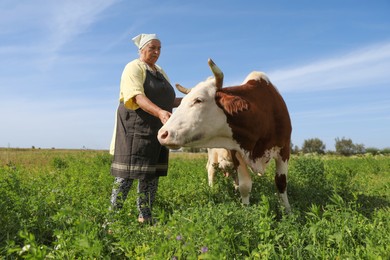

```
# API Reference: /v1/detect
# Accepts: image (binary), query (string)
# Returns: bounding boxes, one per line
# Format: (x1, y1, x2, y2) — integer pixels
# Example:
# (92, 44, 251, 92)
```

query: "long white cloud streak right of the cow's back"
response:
(268, 43, 390, 92)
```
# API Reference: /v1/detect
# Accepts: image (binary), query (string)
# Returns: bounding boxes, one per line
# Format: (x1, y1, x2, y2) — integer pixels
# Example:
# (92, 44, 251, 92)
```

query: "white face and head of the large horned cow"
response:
(158, 59, 242, 149)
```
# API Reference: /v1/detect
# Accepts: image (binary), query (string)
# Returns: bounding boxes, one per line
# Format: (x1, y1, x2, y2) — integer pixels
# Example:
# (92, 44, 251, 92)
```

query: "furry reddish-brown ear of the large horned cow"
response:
(215, 91, 249, 115)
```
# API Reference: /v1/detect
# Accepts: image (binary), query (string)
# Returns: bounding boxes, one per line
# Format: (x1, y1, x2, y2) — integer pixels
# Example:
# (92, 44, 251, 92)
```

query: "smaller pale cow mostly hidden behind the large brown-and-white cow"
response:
(206, 148, 239, 188)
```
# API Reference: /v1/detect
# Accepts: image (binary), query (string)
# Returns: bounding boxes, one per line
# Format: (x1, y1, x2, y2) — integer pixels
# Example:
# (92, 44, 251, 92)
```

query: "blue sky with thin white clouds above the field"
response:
(0, 0, 390, 150)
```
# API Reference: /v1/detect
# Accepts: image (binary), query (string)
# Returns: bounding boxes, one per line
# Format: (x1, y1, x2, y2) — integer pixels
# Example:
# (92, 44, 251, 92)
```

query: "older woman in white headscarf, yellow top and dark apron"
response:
(110, 34, 181, 223)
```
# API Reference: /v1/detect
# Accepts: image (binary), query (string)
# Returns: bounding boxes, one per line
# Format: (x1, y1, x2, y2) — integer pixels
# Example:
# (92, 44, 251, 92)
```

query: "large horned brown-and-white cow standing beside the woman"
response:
(158, 59, 292, 212)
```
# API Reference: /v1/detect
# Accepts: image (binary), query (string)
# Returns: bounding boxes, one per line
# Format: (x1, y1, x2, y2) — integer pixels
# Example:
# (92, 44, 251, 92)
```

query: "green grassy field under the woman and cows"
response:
(0, 149, 390, 259)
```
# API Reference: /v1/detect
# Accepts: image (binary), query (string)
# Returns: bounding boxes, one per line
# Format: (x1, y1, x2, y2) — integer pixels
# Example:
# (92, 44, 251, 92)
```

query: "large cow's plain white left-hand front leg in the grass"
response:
(235, 152, 252, 205)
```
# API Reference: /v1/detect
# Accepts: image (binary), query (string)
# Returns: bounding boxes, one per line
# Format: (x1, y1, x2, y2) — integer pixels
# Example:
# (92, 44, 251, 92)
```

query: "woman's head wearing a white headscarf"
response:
(133, 34, 161, 65)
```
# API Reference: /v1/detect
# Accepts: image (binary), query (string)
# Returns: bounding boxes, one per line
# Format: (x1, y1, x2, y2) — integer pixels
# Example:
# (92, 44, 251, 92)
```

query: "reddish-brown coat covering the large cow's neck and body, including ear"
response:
(215, 79, 292, 161)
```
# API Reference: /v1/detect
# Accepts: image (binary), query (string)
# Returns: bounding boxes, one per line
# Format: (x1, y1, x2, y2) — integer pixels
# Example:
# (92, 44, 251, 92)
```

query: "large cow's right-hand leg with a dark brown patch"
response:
(275, 157, 291, 213)
